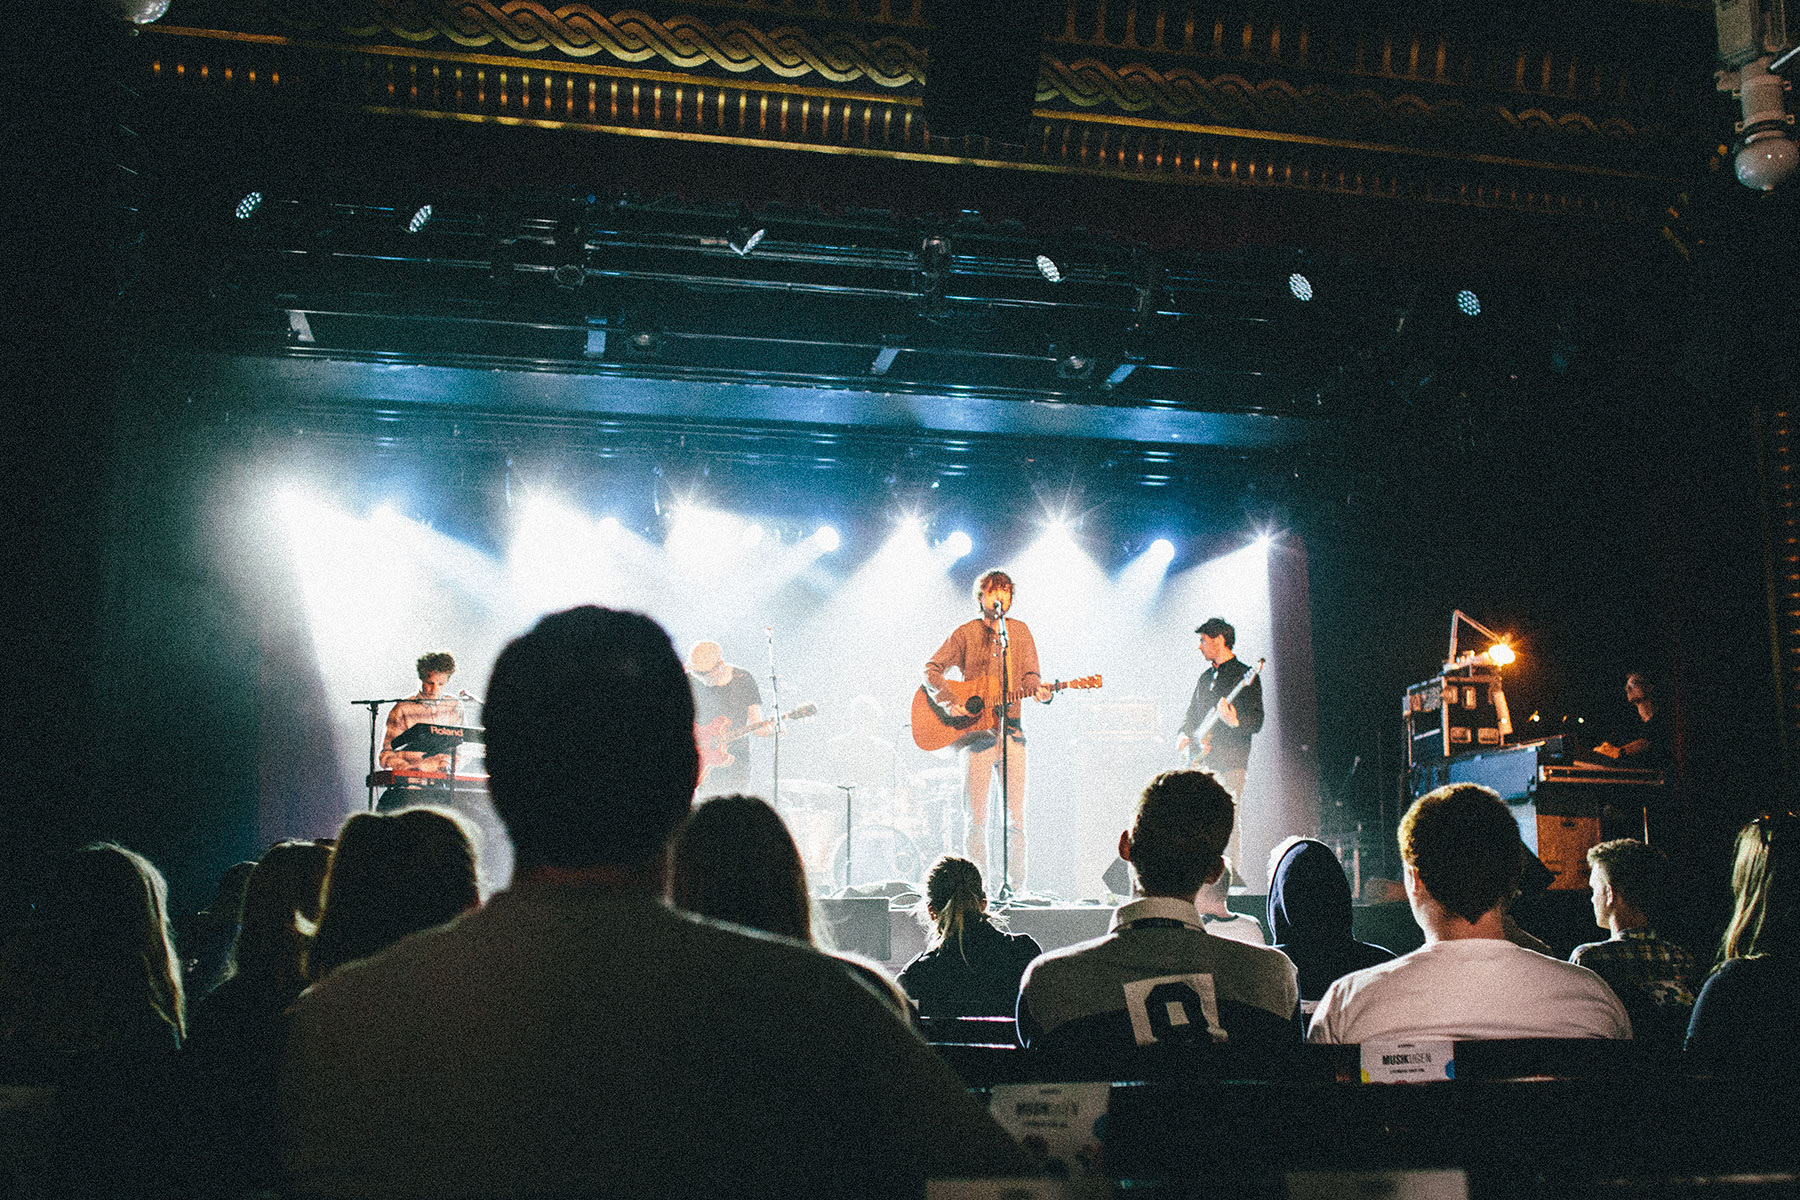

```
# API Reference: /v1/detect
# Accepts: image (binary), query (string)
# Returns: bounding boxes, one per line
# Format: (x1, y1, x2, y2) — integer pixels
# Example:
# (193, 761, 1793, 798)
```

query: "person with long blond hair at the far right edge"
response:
(1687, 813, 1800, 1074)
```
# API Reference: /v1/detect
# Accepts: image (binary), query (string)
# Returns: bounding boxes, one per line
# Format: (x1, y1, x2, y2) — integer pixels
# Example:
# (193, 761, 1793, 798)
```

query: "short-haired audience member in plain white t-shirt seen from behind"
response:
(1309, 783, 1631, 1043)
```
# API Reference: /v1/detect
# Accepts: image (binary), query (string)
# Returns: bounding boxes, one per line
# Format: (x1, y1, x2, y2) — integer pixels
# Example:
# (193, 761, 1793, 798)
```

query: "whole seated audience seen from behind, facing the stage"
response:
(0, 606, 1800, 1196)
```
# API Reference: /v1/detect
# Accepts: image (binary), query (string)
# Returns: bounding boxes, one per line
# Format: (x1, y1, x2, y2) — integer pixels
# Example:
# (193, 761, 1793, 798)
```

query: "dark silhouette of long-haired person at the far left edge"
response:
(0, 842, 185, 1196)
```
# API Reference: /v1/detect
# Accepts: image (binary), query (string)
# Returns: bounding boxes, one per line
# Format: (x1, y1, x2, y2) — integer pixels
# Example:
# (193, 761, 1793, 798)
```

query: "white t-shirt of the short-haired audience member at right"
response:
(1307, 937, 1631, 1043)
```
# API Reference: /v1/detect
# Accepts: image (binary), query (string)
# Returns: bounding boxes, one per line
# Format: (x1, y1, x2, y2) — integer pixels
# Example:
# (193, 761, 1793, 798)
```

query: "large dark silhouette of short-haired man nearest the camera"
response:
(281, 606, 1026, 1200)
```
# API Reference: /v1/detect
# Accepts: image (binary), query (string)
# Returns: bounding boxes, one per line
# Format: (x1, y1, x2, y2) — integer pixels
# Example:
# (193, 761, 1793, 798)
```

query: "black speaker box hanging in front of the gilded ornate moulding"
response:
(923, 0, 1044, 146)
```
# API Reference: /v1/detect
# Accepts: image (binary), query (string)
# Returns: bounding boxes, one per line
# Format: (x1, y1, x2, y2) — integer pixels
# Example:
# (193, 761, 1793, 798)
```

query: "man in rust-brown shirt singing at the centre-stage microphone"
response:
(925, 570, 1055, 887)
